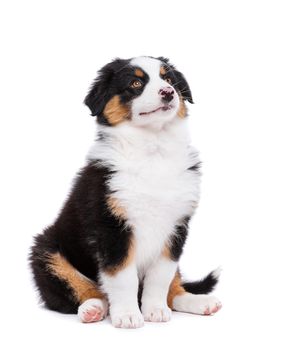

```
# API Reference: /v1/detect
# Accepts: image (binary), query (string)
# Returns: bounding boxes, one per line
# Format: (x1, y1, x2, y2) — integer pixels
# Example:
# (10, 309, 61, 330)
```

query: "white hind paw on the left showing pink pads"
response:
(77, 298, 108, 323)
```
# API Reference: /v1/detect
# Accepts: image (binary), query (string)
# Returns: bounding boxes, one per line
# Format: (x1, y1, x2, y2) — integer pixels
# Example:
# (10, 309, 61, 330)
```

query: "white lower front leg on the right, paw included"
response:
(141, 255, 177, 322)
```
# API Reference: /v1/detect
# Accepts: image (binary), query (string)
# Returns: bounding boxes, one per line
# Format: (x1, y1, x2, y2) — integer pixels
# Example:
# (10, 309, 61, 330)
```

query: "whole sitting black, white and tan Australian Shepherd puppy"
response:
(30, 57, 221, 328)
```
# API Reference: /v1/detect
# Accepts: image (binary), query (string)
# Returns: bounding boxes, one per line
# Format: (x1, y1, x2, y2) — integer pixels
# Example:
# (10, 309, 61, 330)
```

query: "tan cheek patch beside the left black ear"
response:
(103, 95, 130, 125)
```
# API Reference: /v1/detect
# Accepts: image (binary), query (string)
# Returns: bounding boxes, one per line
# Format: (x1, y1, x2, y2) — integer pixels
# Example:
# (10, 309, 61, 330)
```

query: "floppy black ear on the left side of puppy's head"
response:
(84, 58, 125, 124)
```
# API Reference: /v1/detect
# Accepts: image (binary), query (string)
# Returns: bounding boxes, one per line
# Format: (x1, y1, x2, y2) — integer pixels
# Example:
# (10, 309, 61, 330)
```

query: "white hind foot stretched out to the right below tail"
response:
(173, 293, 222, 315)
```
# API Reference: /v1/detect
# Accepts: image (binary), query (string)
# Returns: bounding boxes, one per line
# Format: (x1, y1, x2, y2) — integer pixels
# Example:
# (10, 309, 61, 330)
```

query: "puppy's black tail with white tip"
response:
(182, 267, 221, 294)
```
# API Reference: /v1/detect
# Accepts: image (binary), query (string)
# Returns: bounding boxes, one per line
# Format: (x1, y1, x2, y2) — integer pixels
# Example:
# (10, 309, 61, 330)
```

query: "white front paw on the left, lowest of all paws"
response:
(110, 310, 144, 328)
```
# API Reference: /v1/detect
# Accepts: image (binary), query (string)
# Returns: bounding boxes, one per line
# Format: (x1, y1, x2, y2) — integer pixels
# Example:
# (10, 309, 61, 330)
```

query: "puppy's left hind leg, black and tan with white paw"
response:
(30, 241, 108, 322)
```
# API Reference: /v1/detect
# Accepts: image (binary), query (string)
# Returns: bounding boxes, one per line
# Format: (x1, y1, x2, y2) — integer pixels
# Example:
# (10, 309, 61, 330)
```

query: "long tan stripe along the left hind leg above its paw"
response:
(47, 253, 104, 303)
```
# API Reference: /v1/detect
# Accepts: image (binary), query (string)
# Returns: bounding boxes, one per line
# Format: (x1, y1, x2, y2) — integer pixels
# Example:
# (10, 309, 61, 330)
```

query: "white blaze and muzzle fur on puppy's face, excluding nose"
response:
(130, 57, 180, 126)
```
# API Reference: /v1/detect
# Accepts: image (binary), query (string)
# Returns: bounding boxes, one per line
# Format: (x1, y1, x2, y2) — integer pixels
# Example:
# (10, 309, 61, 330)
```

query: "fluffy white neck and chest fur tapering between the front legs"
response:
(88, 120, 199, 270)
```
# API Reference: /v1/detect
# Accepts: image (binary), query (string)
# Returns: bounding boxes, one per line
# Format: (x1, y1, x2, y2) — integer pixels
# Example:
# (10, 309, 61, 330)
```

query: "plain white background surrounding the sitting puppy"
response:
(0, 0, 289, 350)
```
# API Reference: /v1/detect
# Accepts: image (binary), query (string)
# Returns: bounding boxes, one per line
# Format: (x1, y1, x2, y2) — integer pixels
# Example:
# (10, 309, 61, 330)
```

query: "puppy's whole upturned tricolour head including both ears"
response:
(84, 57, 193, 127)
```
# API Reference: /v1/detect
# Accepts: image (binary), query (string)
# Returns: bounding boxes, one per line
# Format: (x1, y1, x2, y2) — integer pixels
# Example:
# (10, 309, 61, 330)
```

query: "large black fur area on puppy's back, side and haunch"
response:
(30, 162, 132, 313)
